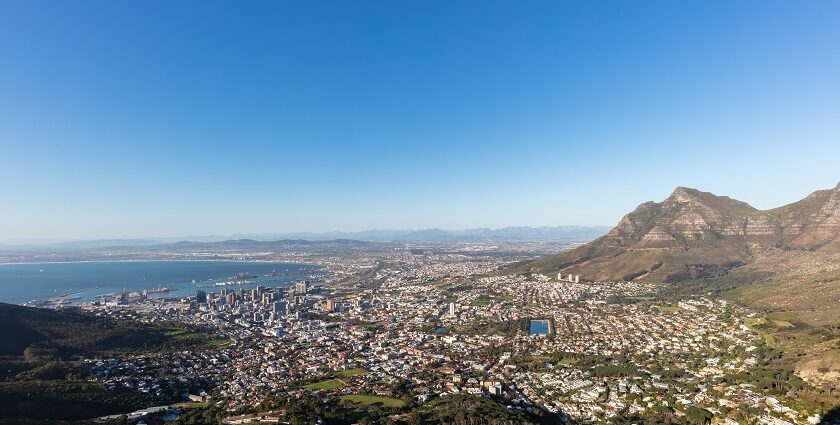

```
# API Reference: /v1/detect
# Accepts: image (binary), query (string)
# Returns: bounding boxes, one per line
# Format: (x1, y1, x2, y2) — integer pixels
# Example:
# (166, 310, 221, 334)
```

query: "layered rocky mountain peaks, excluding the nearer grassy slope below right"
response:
(530, 184, 840, 281)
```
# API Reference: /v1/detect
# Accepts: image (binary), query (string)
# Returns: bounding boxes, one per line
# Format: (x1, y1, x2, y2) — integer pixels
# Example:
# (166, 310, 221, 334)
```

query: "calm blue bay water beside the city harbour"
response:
(0, 261, 321, 304)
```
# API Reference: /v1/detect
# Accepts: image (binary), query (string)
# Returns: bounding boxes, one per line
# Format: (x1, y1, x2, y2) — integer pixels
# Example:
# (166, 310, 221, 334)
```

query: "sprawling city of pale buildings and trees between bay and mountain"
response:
(70, 244, 819, 425)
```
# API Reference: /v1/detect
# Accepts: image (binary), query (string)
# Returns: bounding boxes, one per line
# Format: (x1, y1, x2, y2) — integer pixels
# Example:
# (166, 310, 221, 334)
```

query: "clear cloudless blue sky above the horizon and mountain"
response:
(0, 0, 840, 240)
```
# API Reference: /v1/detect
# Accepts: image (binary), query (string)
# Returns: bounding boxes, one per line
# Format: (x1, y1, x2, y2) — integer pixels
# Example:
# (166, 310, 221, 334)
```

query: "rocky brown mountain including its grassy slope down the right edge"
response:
(528, 185, 840, 388)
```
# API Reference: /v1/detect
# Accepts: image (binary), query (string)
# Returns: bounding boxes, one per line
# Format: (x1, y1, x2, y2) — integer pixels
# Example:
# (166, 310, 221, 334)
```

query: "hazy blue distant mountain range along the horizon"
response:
(0, 226, 609, 250)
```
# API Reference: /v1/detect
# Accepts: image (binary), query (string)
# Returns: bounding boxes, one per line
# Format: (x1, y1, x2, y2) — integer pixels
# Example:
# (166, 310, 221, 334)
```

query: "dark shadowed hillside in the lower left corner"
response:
(0, 303, 223, 424)
